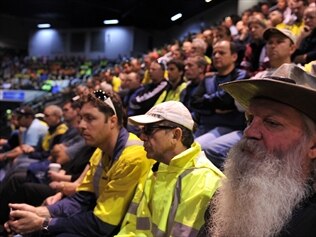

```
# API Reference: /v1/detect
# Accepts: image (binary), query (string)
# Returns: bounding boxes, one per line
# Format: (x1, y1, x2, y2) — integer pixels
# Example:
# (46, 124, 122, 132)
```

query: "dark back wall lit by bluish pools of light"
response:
(0, 0, 237, 59)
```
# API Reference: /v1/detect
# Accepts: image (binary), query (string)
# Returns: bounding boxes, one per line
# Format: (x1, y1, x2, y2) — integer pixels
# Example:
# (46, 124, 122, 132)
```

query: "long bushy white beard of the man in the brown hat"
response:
(208, 138, 309, 237)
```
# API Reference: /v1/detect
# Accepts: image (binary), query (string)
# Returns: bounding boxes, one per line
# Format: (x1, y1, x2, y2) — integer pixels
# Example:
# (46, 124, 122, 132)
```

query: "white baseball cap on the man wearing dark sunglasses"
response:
(128, 101, 194, 131)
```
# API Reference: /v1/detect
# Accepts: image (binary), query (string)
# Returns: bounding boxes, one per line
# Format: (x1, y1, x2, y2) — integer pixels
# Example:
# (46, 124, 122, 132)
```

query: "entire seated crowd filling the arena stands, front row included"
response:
(0, 0, 316, 237)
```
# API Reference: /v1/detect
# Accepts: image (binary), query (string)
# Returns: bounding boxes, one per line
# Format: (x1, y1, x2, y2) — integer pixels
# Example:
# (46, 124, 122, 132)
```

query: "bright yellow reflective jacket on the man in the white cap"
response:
(117, 143, 224, 237)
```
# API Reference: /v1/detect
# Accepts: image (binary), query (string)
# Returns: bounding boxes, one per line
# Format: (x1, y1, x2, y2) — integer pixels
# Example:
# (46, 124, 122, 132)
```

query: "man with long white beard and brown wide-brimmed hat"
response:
(199, 64, 316, 236)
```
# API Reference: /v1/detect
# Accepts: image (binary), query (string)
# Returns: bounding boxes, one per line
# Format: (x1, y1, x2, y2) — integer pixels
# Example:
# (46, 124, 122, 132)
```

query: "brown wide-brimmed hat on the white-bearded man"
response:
(220, 64, 316, 121)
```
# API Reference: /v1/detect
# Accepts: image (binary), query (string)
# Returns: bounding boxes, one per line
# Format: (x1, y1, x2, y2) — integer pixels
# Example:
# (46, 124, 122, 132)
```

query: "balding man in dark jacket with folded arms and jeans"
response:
(191, 40, 247, 149)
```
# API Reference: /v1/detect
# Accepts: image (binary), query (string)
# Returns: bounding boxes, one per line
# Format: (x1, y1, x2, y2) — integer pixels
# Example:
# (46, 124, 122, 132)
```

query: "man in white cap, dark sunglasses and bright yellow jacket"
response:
(118, 101, 223, 236)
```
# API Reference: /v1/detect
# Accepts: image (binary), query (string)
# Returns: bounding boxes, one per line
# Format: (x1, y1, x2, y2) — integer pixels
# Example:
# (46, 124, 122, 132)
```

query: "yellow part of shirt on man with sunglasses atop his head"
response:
(77, 133, 153, 225)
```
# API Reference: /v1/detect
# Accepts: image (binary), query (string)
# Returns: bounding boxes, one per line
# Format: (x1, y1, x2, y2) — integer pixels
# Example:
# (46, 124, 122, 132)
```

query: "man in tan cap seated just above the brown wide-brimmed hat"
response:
(254, 28, 296, 78)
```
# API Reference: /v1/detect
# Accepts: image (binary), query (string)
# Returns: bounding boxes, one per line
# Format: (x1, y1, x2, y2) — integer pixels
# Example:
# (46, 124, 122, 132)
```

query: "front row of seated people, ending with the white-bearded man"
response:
(0, 60, 316, 237)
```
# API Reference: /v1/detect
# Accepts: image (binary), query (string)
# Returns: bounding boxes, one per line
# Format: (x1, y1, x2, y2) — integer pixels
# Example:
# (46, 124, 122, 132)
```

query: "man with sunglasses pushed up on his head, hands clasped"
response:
(5, 91, 152, 237)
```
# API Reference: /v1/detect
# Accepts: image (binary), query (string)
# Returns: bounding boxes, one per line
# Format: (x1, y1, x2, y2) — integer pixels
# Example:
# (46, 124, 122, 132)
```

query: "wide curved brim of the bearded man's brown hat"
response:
(220, 78, 316, 121)
